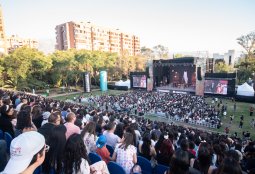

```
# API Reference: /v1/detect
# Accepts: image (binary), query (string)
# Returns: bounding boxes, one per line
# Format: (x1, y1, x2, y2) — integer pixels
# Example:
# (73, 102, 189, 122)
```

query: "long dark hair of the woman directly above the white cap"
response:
(16, 110, 32, 131)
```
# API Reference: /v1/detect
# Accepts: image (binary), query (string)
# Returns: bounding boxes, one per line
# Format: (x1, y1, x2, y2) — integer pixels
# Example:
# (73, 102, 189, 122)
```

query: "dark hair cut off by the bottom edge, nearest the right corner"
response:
(217, 158, 242, 174)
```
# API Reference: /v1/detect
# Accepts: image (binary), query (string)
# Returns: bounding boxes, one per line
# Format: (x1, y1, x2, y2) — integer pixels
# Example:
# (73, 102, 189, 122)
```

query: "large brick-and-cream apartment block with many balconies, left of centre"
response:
(55, 21, 140, 56)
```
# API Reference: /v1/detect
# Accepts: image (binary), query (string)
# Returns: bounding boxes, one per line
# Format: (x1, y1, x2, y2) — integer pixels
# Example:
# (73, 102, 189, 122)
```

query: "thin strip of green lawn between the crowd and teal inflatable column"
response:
(52, 90, 128, 100)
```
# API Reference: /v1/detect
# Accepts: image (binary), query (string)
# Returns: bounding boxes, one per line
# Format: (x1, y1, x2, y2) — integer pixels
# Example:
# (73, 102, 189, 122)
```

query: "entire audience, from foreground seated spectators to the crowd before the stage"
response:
(0, 90, 255, 174)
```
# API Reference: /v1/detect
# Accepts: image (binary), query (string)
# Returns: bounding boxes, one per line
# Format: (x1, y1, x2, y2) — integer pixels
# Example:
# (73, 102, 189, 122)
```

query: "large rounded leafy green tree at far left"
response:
(4, 47, 51, 89)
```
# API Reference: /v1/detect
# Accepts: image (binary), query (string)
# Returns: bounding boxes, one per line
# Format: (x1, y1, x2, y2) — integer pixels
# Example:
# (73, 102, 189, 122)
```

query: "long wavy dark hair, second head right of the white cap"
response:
(63, 134, 88, 174)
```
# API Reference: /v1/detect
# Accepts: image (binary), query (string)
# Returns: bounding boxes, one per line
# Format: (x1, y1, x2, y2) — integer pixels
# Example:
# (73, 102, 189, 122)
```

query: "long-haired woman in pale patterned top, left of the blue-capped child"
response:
(81, 121, 97, 153)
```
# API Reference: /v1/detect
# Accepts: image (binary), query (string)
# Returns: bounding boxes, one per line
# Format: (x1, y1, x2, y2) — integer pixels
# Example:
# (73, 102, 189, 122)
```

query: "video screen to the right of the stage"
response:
(205, 79, 228, 95)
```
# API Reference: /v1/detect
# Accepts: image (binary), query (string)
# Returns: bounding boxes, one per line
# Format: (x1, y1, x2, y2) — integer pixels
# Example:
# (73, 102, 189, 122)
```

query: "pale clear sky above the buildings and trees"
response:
(0, 0, 255, 53)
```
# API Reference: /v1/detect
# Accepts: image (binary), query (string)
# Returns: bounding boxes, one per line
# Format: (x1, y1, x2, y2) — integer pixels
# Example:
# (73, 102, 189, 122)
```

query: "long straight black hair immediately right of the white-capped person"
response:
(43, 125, 66, 173)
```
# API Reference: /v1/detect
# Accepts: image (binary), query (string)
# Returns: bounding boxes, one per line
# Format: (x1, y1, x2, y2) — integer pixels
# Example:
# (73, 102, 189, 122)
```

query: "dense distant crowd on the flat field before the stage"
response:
(85, 91, 221, 127)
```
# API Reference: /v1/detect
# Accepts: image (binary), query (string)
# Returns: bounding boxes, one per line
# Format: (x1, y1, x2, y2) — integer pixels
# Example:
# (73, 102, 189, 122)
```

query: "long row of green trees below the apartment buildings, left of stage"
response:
(0, 47, 146, 89)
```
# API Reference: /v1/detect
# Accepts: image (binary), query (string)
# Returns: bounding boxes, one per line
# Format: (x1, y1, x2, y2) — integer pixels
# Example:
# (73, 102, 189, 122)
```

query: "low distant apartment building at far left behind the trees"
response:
(6, 35, 38, 53)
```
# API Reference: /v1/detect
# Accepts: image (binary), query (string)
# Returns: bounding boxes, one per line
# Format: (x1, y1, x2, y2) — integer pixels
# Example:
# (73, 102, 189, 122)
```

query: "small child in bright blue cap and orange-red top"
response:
(96, 135, 113, 164)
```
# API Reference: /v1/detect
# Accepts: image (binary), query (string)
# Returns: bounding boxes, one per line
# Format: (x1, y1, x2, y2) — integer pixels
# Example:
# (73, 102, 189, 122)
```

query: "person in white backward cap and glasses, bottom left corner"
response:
(1, 131, 46, 174)
